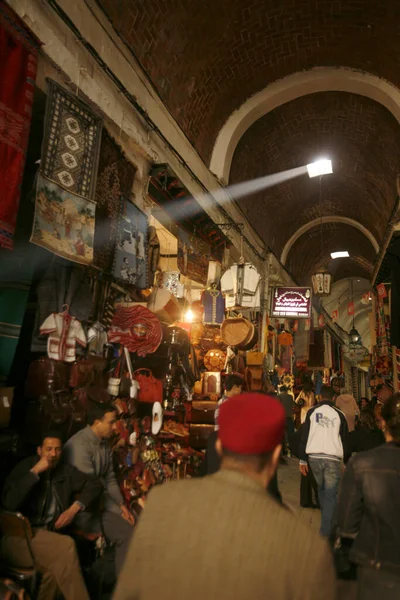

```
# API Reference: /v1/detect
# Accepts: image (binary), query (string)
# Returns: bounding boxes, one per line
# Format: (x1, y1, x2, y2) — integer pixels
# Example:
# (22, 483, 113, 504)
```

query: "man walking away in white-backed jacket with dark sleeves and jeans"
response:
(299, 386, 350, 537)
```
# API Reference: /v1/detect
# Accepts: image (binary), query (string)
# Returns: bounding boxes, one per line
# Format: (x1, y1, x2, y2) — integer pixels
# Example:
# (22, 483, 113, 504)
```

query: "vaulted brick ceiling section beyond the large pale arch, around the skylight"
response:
(231, 92, 400, 277)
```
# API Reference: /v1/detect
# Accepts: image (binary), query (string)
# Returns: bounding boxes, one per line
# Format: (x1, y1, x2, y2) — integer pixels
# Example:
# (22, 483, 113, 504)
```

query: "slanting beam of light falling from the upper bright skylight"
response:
(162, 165, 307, 220)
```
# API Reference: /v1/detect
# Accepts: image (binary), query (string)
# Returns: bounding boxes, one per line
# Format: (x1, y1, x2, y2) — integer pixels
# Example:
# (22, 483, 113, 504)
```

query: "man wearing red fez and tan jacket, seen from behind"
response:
(114, 393, 336, 600)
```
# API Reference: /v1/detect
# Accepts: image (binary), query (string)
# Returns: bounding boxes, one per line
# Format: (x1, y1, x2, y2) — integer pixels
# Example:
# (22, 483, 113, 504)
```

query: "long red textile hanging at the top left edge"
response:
(0, 2, 40, 250)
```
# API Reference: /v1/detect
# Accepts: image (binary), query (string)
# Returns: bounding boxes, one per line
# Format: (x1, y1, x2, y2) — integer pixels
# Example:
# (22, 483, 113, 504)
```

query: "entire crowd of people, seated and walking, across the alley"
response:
(0, 374, 400, 600)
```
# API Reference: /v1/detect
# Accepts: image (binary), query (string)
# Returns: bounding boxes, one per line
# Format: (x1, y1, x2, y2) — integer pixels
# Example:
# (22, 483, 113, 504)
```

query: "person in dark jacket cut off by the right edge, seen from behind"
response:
(338, 394, 400, 600)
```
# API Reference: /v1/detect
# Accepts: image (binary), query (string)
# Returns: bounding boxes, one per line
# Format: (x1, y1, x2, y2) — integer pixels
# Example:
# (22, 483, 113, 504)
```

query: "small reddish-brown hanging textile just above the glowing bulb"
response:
(178, 229, 211, 285)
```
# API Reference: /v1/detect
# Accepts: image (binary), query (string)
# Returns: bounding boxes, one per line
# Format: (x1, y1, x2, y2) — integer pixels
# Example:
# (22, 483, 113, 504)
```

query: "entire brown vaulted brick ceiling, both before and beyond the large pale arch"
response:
(98, 0, 400, 280)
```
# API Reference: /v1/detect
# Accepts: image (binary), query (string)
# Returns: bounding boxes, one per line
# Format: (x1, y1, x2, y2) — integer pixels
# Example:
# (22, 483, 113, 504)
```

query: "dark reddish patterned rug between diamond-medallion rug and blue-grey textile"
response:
(94, 129, 136, 273)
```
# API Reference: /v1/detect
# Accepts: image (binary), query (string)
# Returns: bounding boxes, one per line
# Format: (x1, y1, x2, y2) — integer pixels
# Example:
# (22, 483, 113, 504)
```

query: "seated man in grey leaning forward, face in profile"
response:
(64, 403, 134, 573)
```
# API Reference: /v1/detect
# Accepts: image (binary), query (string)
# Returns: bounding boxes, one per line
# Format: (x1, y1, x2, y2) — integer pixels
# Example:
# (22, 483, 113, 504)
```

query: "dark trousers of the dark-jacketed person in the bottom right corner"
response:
(357, 567, 400, 600)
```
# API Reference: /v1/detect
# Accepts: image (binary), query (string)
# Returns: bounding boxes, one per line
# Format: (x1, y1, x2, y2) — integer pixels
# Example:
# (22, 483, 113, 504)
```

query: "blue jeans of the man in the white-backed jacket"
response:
(308, 456, 342, 537)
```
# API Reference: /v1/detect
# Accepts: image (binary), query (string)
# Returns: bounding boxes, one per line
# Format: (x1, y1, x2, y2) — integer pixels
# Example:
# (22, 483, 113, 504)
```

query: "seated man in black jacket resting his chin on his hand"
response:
(1, 432, 102, 600)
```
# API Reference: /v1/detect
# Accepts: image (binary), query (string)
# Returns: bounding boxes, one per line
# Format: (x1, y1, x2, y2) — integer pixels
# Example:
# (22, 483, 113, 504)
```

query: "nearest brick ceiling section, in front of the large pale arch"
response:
(98, 0, 400, 162)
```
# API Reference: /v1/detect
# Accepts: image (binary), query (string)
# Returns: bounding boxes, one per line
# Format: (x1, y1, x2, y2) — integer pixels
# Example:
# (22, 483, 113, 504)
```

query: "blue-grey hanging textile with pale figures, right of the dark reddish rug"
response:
(113, 200, 148, 290)
